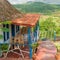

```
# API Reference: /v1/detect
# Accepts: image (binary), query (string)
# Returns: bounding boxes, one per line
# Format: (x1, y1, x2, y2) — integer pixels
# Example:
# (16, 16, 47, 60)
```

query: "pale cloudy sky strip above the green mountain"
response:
(8, 0, 60, 4)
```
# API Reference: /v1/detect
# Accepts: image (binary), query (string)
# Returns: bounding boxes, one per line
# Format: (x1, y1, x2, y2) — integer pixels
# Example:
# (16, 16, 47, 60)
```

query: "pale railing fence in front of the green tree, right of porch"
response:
(39, 31, 56, 40)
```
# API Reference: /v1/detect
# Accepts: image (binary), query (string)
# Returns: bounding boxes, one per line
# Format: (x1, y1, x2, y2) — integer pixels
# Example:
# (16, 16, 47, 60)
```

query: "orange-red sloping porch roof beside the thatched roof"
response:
(12, 14, 40, 27)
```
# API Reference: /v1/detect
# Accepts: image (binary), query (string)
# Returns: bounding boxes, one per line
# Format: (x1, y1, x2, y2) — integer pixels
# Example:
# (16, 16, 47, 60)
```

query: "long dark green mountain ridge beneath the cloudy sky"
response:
(14, 1, 60, 14)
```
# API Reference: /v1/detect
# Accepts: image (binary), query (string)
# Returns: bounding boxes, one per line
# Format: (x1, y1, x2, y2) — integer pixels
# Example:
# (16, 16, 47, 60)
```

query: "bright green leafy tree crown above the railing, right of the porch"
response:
(40, 17, 56, 31)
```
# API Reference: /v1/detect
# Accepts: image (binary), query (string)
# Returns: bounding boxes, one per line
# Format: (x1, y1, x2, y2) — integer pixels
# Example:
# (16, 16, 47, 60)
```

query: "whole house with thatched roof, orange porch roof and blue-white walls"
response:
(0, 0, 40, 58)
